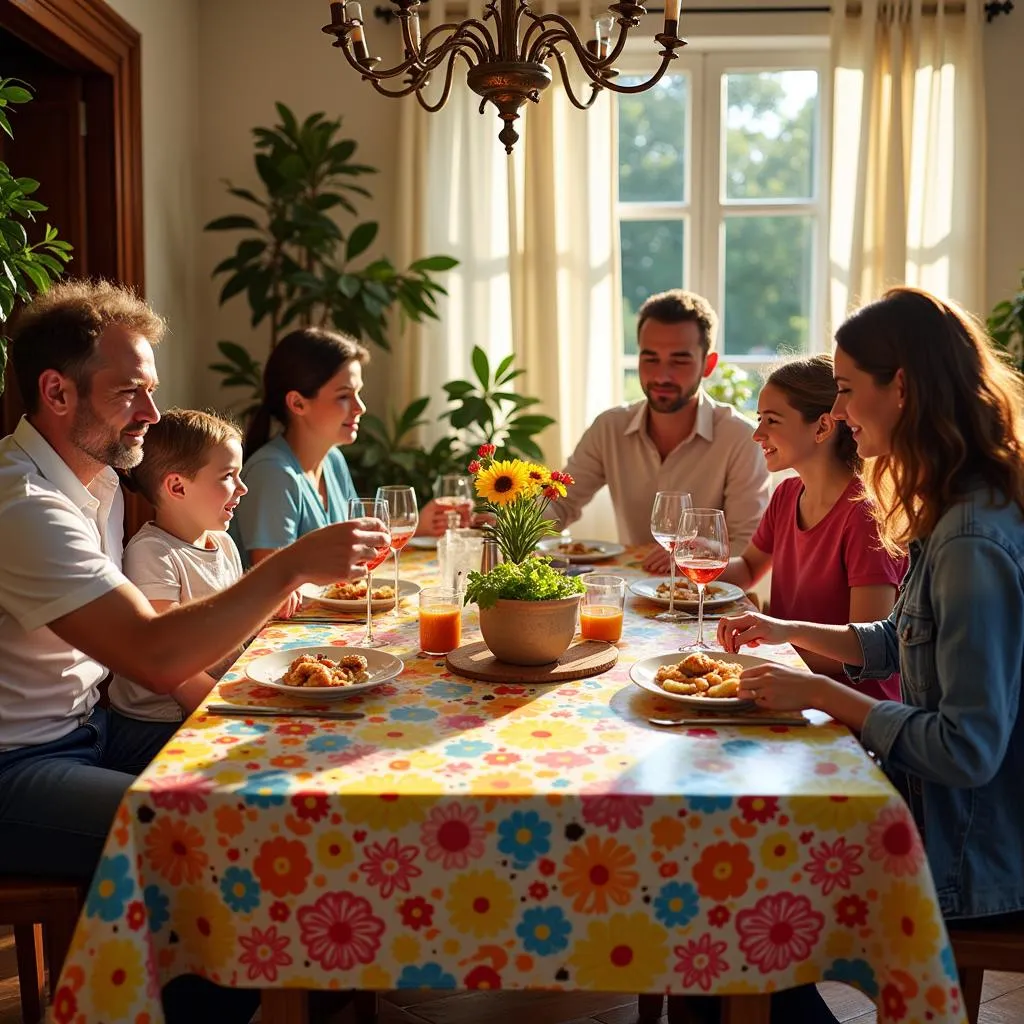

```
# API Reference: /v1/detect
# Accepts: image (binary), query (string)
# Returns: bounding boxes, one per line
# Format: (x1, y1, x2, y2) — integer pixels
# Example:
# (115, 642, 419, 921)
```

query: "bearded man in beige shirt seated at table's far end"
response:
(550, 290, 769, 572)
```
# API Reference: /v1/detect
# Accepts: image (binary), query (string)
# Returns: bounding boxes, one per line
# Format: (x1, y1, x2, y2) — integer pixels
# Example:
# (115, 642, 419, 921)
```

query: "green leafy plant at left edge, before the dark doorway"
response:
(0, 78, 72, 394)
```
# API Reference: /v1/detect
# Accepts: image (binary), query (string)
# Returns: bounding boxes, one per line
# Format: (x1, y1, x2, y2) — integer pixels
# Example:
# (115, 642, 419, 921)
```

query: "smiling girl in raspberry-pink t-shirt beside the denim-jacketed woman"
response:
(722, 355, 906, 700)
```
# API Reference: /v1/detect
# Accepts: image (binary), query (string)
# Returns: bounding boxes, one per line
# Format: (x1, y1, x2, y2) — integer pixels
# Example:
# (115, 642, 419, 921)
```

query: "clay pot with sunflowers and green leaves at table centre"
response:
(466, 444, 584, 665)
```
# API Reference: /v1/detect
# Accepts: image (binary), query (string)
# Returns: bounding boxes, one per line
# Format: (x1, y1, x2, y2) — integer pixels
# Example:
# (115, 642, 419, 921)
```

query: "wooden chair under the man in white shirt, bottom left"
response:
(0, 878, 85, 1024)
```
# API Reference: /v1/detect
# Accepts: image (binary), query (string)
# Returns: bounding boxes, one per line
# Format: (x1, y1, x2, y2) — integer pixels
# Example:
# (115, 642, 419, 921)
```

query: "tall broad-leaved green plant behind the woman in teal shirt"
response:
(206, 103, 458, 407)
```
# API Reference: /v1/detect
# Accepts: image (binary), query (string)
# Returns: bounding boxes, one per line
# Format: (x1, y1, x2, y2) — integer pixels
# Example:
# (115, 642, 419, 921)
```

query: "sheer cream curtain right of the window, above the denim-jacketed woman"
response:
(829, 0, 986, 329)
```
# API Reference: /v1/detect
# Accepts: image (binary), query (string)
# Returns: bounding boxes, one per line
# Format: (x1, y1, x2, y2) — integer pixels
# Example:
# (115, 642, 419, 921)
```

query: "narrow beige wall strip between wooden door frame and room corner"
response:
(102, 0, 200, 408)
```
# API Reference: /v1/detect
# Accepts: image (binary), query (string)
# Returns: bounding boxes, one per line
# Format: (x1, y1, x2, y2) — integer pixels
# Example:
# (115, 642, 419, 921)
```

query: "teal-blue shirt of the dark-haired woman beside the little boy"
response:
(228, 435, 358, 569)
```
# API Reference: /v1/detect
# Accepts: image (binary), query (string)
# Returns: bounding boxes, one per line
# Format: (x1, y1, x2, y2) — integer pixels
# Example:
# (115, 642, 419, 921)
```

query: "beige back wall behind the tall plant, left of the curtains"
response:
(198, 0, 398, 408)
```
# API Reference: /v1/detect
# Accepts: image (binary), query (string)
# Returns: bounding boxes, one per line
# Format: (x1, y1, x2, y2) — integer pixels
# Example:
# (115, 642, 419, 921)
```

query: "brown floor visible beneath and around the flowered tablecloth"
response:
(0, 929, 1024, 1024)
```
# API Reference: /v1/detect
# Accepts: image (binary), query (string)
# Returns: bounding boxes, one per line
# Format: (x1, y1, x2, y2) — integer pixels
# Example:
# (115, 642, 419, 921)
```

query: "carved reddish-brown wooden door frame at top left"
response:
(0, 0, 145, 295)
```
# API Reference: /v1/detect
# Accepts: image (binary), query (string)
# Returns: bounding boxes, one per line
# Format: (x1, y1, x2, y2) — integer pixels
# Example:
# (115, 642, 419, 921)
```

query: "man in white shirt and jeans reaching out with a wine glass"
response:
(0, 282, 386, 879)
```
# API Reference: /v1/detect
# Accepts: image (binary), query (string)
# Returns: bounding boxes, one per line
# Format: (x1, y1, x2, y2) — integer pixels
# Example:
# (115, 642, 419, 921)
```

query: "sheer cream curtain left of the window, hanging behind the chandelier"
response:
(398, 0, 622, 475)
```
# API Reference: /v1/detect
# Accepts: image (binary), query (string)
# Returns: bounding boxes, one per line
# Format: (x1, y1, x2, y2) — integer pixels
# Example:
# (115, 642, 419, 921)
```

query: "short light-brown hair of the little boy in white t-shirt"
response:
(131, 409, 242, 505)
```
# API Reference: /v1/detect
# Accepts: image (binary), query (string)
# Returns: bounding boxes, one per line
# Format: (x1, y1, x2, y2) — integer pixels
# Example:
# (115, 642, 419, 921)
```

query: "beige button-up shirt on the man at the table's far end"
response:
(548, 390, 769, 555)
